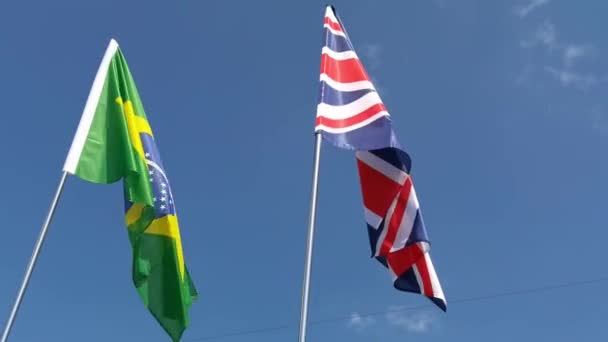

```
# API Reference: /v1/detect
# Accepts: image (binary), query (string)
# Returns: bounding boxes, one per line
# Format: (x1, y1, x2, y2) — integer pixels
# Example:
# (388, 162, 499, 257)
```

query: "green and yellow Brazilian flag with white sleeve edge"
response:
(64, 40, 197, 341)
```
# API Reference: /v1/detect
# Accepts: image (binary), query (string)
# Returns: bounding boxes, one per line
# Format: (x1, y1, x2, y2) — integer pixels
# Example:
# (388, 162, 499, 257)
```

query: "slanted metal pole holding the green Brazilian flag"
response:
(0, 171, 68, 342)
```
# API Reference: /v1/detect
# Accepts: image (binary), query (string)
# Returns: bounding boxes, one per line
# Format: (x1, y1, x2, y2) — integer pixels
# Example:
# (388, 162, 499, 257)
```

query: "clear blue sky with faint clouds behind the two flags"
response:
(0, 0, 608, 342)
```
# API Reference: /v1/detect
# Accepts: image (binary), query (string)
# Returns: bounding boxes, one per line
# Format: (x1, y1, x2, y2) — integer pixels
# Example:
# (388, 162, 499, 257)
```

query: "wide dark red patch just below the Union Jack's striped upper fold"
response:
(357, 159, 401, 217)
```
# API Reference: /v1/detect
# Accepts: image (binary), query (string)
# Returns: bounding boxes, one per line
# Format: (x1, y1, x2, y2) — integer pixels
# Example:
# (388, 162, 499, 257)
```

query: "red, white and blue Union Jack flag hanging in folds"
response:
(315, 6, 447, 311)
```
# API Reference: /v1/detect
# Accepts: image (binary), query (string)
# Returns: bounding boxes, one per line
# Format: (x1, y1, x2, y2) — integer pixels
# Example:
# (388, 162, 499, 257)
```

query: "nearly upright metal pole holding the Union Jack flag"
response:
(299, 133, 321, 342)
